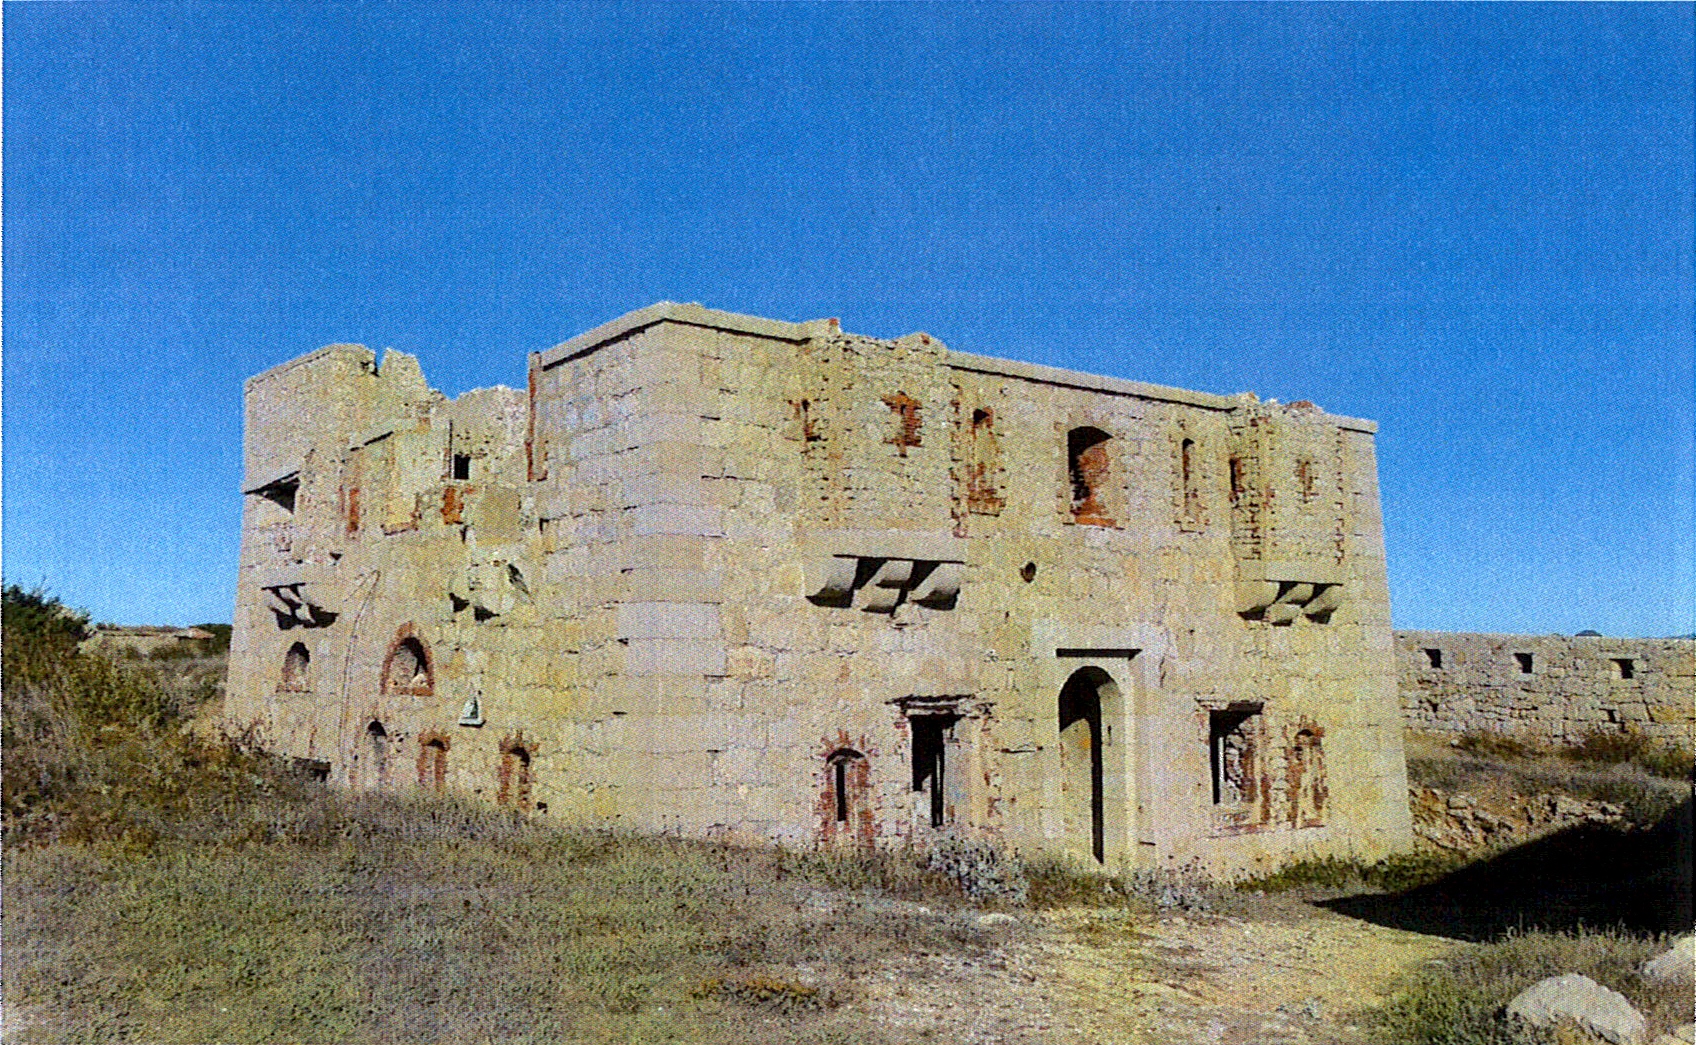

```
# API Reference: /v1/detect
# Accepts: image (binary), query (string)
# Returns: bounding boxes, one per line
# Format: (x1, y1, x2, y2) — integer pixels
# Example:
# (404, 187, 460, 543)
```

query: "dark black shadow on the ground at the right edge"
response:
(1323, 787, 1696, 942)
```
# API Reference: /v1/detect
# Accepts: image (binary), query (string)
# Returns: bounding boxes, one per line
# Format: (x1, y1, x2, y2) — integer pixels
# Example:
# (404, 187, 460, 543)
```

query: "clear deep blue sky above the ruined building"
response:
(3, 2, 1696, 634)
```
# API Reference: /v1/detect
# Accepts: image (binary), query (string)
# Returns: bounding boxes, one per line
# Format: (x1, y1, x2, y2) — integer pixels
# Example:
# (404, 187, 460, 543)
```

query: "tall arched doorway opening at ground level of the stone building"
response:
(1058, 667, 1121, 863)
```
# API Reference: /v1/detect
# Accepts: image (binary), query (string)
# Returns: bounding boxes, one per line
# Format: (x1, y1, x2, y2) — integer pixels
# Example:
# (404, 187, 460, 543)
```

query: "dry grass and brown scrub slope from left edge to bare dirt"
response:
(0, 590, 977, 1045)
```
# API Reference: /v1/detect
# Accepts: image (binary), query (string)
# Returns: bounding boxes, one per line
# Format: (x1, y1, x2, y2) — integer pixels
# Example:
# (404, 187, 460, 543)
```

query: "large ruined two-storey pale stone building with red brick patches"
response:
(226, 304, 1409, 870)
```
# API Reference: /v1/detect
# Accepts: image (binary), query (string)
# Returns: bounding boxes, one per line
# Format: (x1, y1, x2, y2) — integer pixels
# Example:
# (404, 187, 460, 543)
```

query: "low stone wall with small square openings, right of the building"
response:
(1396, 631, 1696, 748)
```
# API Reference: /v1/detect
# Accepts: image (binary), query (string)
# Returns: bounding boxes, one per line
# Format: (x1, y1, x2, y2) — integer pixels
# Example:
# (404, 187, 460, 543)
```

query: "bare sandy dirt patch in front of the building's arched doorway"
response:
(776, 899, 1453, 1045)
